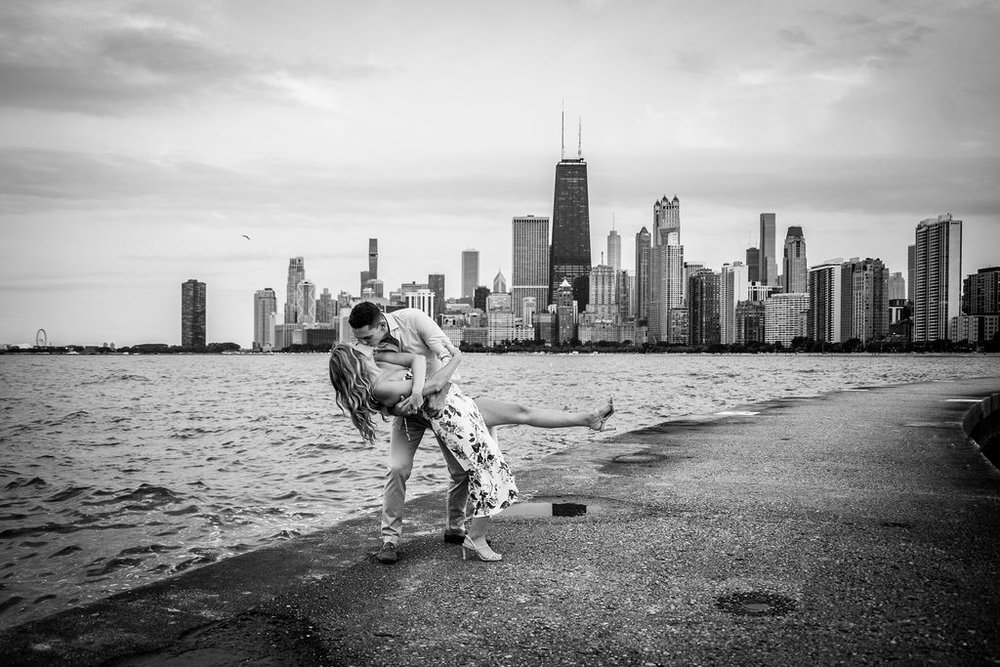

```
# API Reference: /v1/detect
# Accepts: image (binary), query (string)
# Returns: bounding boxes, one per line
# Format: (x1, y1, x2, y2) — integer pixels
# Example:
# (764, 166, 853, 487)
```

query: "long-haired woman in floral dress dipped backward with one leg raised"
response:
(330, 344, 614, 561)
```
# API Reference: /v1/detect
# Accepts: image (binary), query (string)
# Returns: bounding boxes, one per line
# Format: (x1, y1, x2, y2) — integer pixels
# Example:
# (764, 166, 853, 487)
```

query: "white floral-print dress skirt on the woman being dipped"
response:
(424, 384, 517, 517)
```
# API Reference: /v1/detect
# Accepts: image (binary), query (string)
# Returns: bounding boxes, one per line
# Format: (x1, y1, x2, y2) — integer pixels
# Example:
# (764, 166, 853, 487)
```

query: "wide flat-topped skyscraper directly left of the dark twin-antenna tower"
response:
(510, 215, 549, 324)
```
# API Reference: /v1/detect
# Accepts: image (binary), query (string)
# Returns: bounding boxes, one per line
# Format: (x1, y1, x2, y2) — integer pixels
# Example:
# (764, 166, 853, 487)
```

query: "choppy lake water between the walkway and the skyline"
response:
(0, 355, 1000, 627)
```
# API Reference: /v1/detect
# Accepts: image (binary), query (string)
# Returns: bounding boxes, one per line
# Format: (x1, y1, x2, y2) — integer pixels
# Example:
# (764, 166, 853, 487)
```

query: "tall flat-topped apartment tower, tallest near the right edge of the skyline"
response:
(913, 213, 962, 342)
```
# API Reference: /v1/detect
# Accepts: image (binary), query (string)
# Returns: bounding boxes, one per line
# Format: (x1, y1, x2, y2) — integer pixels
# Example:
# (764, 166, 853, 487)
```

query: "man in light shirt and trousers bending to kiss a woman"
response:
(347, 301, 469, 564)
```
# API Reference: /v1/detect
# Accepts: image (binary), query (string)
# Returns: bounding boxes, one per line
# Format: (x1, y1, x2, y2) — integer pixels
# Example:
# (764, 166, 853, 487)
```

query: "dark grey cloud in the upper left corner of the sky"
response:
(0, 2, 379, 116)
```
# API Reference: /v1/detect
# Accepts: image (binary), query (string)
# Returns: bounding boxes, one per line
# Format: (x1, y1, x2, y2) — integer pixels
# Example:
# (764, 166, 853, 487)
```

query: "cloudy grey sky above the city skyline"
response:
(0, 0, 1000, 346)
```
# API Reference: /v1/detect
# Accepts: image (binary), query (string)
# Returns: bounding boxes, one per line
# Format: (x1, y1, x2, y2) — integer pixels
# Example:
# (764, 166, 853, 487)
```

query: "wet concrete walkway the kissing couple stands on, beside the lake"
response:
(0, 378, 1000, 665)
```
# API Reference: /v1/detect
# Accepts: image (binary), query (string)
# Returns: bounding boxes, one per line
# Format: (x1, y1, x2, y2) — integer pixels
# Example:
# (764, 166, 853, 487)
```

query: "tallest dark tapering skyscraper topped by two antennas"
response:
(549, 116, 592, 311)
